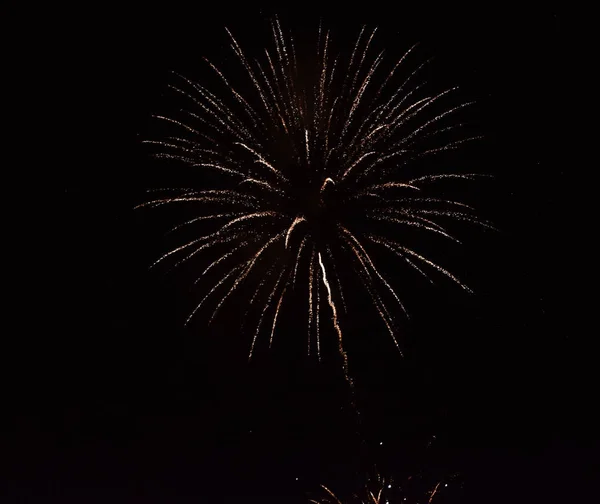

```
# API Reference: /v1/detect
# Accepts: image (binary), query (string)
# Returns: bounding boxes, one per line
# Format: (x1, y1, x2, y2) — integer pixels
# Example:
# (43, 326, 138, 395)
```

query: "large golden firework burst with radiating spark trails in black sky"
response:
(140, 19, 491, 370)
